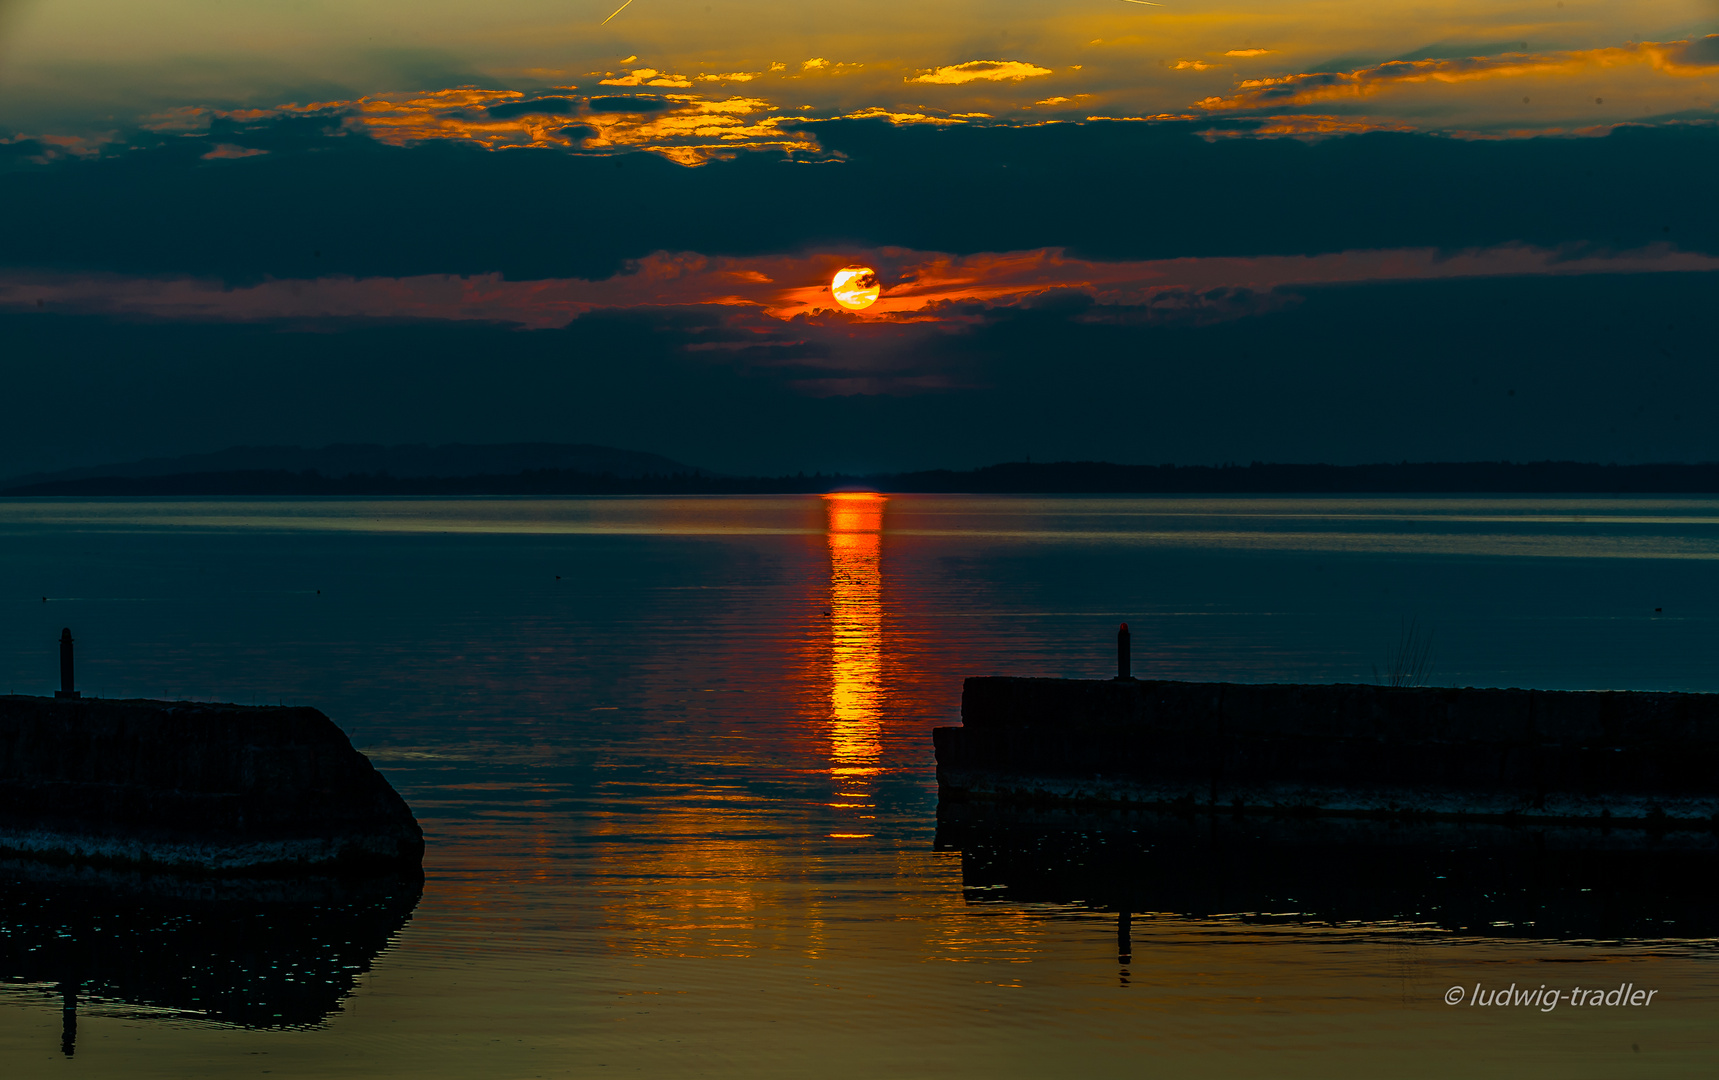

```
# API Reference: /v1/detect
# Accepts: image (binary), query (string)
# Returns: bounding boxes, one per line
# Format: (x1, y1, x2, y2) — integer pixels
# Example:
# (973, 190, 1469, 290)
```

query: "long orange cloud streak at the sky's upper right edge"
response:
(1195, 34, 1719, 112)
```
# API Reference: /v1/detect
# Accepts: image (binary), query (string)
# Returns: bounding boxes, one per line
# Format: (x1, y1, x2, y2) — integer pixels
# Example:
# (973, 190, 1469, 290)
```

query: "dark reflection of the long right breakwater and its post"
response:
(937, 801, 1719, 954)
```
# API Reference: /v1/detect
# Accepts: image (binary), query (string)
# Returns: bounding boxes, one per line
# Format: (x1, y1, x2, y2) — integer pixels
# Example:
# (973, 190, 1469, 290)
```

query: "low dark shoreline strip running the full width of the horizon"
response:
(10, 461, 1719, 499)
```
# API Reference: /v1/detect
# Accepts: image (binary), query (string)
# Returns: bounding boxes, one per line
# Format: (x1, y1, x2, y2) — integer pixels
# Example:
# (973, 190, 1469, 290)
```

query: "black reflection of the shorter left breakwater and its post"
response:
(0, 860, 423, 1056)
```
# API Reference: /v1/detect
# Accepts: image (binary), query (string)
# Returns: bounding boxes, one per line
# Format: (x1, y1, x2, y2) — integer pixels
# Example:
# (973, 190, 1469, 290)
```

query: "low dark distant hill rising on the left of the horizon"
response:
(0, 442, 708, 488)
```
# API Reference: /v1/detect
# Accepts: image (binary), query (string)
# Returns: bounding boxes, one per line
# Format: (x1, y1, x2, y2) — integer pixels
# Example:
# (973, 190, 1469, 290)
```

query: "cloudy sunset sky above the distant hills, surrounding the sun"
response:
(0, 0, 1719, 475)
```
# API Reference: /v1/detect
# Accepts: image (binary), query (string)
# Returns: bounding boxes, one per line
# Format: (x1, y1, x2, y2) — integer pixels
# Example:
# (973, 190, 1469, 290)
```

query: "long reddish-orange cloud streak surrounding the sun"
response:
(0, 244, 1719, 328)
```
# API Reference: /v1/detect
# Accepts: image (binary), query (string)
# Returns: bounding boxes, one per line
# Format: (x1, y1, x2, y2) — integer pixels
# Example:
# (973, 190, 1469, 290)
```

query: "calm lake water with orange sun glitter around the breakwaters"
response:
(0, 495, 1719, 1078)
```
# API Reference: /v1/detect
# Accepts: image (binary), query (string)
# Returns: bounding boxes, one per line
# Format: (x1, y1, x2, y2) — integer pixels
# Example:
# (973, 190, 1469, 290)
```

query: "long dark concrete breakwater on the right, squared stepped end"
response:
(933, 678, 1719, 829)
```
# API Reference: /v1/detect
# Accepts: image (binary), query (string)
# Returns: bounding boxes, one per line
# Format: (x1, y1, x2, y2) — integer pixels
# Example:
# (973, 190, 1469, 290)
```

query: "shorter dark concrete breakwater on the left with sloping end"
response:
(0, 696, 425, 874)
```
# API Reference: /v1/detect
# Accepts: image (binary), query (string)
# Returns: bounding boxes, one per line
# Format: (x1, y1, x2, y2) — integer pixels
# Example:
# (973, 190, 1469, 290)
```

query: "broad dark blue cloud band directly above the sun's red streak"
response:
(0, 117, 1719, 282)
